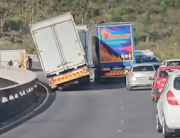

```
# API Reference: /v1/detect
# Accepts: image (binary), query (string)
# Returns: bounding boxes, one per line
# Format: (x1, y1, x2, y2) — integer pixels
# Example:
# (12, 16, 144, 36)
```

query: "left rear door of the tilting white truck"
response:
(32, 26, 64, 74)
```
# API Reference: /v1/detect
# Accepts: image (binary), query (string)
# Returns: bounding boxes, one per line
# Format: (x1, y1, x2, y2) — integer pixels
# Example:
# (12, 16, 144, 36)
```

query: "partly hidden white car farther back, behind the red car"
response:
(161, 59, 180, 67)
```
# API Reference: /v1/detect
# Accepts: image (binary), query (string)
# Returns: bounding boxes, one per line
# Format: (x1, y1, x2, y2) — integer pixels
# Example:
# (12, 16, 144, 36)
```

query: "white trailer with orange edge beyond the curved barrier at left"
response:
(0, 49, 26, 69)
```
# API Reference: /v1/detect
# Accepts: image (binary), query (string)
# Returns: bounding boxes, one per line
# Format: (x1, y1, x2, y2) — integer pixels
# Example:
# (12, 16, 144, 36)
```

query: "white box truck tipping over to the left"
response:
(30, 13, 90, 89)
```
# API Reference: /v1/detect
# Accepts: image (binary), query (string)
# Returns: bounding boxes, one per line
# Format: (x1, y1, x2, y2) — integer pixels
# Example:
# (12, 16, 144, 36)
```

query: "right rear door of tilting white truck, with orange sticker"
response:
(54, 19, 85, 68)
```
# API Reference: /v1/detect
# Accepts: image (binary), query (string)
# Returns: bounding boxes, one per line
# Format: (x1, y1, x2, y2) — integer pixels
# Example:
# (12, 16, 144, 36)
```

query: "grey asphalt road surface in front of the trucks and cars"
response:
(0, 62, 162, 138)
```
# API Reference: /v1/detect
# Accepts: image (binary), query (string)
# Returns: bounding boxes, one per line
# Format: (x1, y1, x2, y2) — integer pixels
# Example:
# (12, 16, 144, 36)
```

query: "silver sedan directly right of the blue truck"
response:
(126, 64, 156, 91)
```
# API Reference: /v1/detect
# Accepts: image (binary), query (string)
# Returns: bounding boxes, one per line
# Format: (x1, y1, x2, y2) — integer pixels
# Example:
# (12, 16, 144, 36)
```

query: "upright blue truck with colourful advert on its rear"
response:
(91, 23, 136, 81)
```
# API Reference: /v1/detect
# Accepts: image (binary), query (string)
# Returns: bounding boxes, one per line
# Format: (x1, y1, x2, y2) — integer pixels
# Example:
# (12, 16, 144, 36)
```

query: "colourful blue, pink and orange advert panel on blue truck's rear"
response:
(98, 24, 134, 63)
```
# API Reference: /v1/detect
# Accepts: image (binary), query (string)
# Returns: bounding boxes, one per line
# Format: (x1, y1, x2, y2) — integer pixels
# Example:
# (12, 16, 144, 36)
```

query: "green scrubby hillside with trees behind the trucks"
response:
(0, 0, 180, 59)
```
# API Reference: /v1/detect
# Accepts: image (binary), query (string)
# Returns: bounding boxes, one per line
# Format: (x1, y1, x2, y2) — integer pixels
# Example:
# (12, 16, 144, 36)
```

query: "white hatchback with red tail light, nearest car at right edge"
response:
(156, 71, 180, 138)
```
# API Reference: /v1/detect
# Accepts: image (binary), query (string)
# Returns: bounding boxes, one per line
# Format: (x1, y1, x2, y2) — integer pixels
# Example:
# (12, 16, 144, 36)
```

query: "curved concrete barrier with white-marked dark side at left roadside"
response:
(0, 66, 39, 121)
